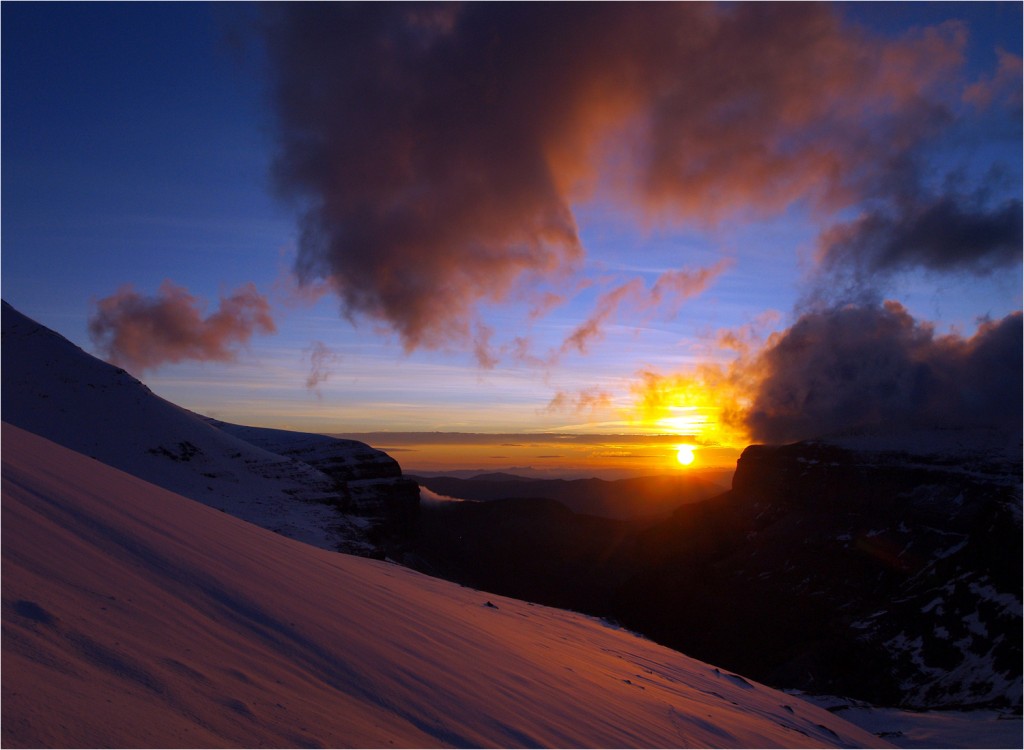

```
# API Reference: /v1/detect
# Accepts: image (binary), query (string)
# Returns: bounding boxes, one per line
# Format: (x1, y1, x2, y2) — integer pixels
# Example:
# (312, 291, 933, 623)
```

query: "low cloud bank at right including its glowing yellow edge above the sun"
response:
(633, 301, 1024, 445)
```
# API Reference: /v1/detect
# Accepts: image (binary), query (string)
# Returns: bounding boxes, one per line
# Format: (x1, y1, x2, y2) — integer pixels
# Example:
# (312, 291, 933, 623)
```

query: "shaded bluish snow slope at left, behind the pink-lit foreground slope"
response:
(2, 302, 386, 553)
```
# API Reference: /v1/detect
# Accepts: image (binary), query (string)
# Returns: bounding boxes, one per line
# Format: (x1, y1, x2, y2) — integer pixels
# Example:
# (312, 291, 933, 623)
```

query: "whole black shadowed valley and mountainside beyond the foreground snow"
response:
(407, 431, 1022, 710)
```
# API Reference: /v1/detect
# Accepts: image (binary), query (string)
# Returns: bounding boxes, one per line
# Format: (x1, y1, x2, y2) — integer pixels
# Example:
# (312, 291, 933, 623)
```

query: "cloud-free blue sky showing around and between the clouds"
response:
(2, 3, 1021, 469)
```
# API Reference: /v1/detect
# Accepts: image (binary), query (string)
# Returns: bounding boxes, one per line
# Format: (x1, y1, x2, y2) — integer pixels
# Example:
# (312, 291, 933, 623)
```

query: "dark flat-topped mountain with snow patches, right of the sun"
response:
(616, 435, 1022, 708)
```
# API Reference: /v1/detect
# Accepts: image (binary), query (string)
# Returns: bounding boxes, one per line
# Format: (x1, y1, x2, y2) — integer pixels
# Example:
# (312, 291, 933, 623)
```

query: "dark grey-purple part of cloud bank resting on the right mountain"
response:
(742, 302, 1024, 443)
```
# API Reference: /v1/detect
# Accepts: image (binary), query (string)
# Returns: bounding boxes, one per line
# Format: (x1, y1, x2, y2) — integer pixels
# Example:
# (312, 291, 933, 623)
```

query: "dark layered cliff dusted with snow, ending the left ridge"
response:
(211, 420, 420, 555)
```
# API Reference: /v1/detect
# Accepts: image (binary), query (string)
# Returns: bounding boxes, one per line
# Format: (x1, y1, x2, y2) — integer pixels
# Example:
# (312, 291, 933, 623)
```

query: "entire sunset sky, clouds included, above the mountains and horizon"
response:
(0, 2, 1022, 475)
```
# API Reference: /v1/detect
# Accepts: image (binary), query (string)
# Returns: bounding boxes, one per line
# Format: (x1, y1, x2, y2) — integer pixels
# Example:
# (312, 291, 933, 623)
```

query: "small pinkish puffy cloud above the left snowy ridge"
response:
(89, 281, 276, 372)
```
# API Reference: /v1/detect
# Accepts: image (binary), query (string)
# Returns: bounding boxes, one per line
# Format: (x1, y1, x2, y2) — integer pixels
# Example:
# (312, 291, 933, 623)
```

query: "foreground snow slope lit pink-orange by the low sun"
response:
(2, 424, 886, 747)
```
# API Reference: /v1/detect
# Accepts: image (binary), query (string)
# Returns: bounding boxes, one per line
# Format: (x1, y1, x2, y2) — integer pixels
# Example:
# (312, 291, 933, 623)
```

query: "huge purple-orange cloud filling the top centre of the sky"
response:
(265, 3, 966, 352)
